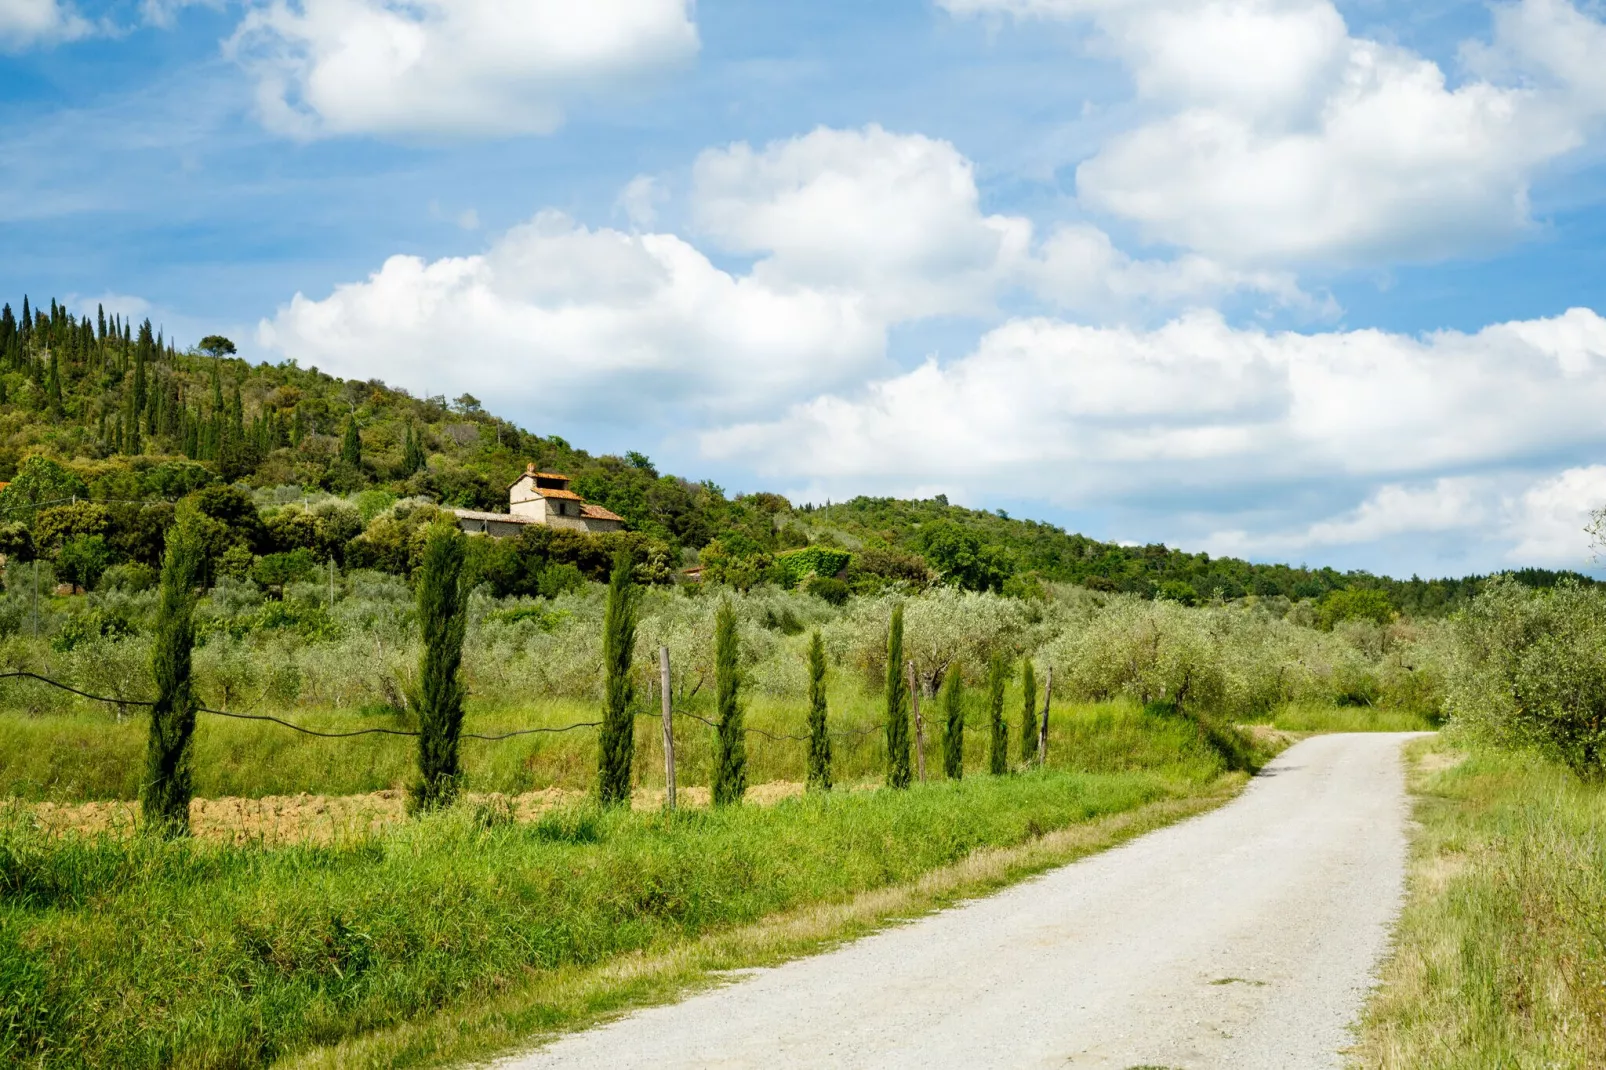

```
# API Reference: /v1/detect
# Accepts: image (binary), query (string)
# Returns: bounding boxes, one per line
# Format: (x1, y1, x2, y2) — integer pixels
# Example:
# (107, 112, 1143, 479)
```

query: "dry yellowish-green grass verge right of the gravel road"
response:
(1354, 739, 1606, 1070)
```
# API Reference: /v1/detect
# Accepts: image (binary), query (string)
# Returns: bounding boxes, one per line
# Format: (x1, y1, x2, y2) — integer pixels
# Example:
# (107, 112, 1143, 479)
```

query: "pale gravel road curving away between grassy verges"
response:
(501, 734, 1408, 1070)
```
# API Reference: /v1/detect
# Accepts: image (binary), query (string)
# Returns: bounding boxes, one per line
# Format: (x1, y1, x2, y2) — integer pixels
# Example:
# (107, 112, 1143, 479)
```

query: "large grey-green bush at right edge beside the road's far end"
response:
(1445, 578, 1606, 781)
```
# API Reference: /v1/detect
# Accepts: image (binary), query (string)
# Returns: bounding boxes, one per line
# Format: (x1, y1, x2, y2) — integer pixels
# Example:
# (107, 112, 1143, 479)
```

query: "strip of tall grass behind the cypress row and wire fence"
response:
(0, 684, 1233, 803)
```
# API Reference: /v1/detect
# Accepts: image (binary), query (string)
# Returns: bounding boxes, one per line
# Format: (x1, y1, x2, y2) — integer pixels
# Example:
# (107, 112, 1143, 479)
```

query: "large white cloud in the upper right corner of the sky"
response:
(944, 0, 1606, 265)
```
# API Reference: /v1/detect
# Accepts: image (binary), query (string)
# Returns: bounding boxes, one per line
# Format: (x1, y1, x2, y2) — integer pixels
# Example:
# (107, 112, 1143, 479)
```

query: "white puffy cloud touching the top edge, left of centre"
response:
(228, 0, 699, 137)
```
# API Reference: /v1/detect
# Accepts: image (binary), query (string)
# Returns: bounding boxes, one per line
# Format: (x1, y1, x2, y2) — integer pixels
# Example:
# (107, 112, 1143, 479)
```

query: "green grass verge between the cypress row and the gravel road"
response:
(0, 748, 1243, 1068)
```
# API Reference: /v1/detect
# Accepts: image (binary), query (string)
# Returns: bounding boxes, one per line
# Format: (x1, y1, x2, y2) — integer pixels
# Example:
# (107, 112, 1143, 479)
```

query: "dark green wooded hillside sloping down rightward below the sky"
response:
(0, 297, 1588, 614)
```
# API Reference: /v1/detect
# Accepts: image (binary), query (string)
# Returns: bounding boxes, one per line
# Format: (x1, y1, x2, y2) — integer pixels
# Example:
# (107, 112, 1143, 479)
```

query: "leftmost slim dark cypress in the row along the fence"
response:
(140, 521, 201, 835)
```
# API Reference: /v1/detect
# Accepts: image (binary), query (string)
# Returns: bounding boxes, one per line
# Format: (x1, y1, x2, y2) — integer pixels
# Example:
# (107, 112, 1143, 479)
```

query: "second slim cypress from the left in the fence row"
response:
(411, 525, 467, 810)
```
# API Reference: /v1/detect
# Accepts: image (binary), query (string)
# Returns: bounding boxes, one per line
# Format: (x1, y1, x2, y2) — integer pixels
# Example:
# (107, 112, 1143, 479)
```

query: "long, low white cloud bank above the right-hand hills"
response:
(703, 308, 1606, 504)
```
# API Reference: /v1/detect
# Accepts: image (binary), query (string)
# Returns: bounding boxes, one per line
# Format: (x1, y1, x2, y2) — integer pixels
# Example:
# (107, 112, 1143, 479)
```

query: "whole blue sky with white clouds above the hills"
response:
(0, 0, 1606, 575)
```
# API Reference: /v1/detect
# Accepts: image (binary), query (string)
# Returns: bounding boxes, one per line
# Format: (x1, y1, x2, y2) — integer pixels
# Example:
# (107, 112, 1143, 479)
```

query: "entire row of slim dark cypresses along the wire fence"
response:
(141, 519, 1059, 835)
